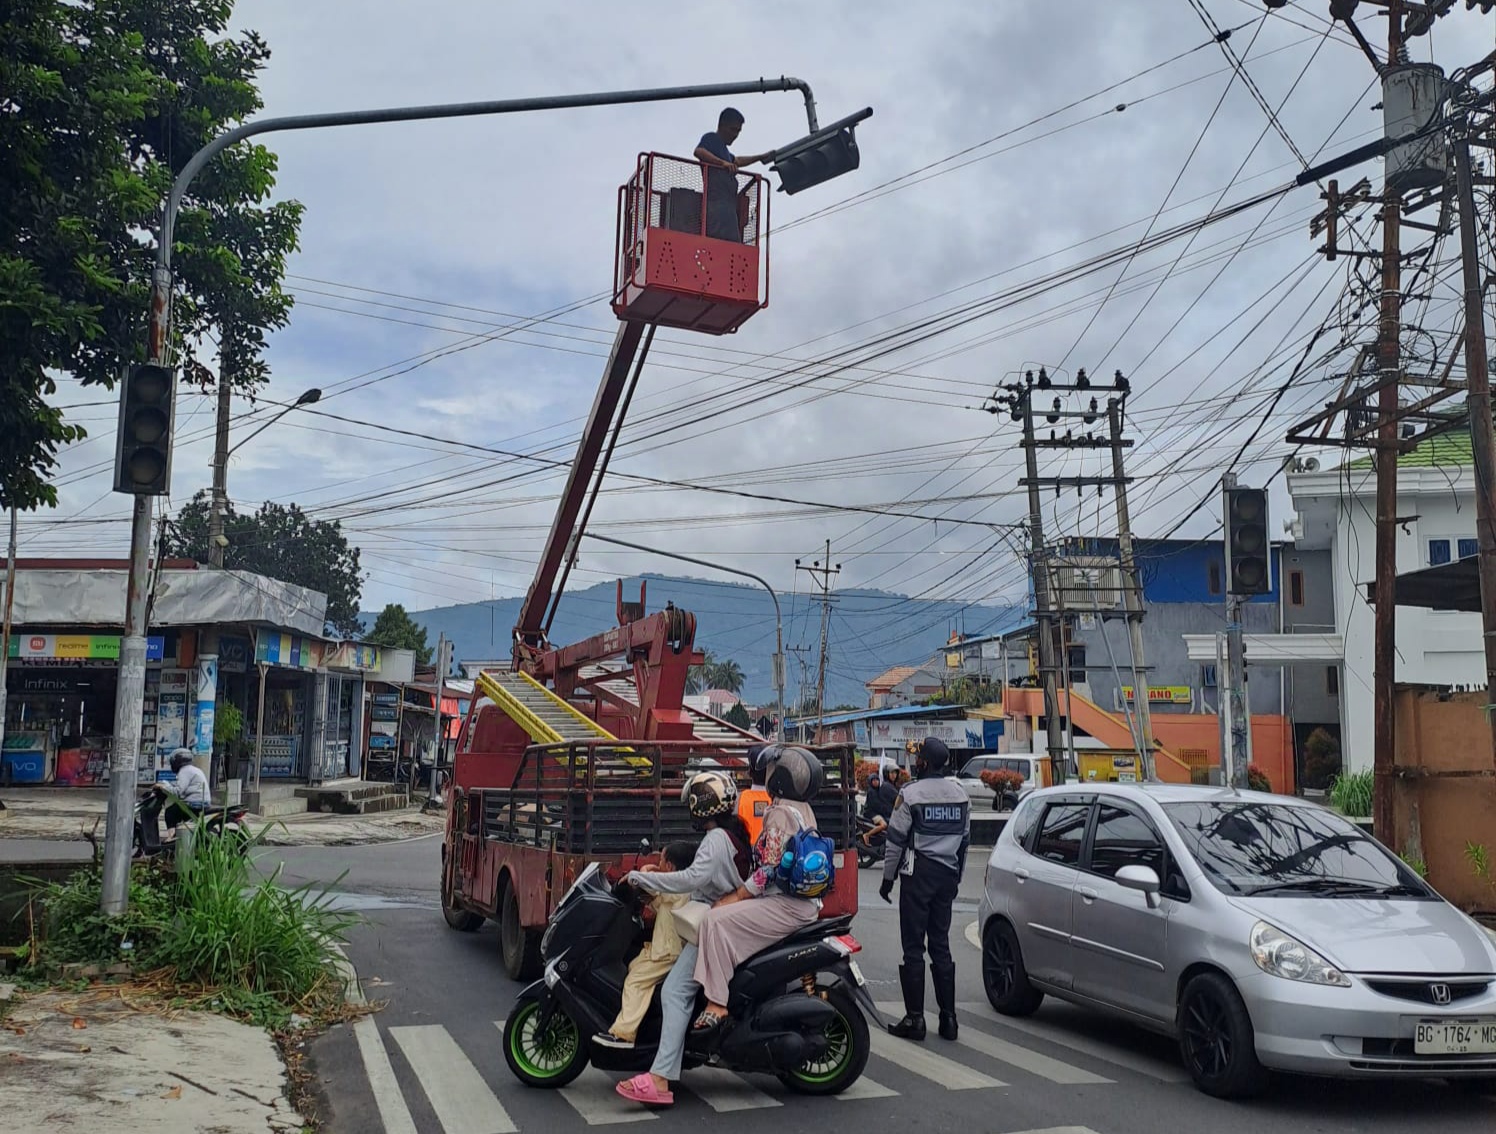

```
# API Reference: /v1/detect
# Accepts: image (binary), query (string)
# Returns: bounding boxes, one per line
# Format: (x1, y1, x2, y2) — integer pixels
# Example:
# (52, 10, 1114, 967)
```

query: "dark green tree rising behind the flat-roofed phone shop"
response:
(166, 492, 364, 637)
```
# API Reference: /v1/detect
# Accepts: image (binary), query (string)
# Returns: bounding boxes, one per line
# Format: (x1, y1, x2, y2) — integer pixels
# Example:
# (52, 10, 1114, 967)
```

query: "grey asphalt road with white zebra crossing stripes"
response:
(251, 838, 1496, 1134)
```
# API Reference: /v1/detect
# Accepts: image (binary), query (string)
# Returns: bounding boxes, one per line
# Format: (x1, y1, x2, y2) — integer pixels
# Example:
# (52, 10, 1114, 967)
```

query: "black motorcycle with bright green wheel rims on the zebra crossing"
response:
(503, 863, 883, 1095)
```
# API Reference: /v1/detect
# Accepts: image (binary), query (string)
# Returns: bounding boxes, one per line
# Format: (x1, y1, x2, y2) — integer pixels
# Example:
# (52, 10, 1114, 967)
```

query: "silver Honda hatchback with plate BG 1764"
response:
(978, 784, 1496, 1098)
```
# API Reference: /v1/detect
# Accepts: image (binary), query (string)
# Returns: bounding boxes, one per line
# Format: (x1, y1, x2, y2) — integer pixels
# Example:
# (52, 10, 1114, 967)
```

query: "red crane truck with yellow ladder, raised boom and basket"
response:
(441, 154, 857, 980)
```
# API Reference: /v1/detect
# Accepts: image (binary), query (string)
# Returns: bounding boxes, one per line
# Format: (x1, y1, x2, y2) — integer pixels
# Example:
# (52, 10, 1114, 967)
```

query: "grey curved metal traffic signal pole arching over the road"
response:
(100, 76, 871, 914)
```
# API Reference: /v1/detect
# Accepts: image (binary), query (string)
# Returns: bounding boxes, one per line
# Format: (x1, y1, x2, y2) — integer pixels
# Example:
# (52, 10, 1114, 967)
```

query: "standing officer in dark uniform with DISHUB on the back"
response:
(878, 736, 971, 1040)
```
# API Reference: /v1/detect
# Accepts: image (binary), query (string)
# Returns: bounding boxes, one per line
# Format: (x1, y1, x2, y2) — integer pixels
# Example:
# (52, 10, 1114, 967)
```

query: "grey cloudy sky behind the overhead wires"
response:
(22, 0, 1496, 667)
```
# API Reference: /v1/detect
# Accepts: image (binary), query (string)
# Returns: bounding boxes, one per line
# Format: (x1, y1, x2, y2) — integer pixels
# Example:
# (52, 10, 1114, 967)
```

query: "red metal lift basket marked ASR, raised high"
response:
(613, 154, 769, 335)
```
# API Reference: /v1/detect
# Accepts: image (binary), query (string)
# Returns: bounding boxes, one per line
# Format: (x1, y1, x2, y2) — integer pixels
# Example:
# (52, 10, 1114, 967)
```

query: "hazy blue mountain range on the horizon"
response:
(362, 574, 1020, 706)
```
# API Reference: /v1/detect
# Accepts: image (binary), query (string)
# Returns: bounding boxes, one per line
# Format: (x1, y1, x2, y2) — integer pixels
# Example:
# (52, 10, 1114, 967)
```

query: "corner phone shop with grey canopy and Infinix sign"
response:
(0, 560, 414, 787)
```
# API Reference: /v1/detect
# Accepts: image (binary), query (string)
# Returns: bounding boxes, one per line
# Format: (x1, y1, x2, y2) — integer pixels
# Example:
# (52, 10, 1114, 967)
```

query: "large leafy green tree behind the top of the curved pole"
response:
(0, 0, 302, 509)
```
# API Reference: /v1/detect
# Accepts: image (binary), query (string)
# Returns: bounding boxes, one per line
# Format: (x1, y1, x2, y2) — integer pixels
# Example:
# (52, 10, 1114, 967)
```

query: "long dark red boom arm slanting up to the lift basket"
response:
(513, 320, 645, 669)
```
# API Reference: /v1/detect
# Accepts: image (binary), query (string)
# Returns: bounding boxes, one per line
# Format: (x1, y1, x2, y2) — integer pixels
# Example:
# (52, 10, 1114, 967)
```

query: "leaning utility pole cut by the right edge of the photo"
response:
(1454, 102, 1496, 758)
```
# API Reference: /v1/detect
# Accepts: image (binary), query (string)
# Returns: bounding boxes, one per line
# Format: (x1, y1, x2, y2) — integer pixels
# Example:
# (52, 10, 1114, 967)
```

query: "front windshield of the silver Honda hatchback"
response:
(1164, 800, 1432, 898)
